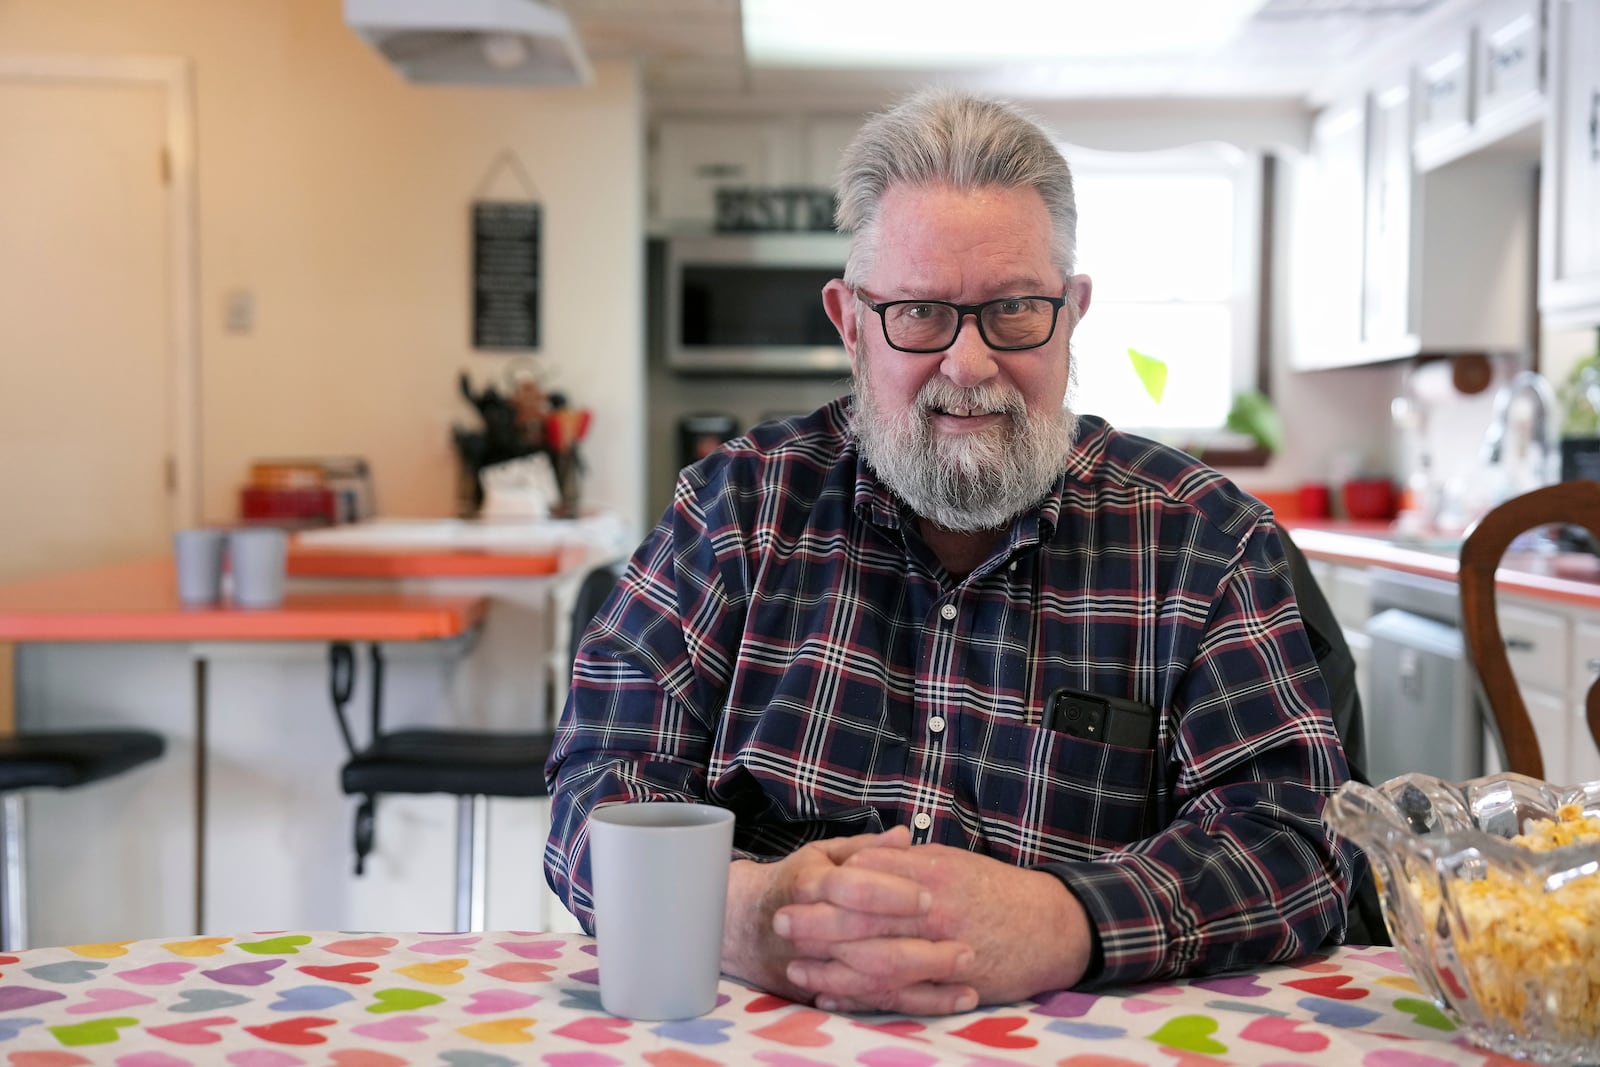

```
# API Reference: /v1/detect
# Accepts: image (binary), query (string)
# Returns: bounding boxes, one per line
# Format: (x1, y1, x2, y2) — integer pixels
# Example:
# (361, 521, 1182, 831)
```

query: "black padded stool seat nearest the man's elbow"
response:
(341, 729, 550, 797)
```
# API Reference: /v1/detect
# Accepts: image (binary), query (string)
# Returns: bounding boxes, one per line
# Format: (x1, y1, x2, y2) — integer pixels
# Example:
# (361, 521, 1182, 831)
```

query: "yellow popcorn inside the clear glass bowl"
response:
(1411, 805, 1600, 1040)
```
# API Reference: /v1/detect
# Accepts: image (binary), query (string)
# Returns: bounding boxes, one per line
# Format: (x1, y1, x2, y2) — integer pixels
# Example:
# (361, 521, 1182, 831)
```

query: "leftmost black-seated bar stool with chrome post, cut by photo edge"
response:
(0, 729, 166, 952)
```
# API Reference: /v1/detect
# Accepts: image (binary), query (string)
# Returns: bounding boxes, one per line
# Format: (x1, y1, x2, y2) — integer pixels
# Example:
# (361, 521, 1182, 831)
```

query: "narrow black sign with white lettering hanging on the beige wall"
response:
(472, 200, 539, 349)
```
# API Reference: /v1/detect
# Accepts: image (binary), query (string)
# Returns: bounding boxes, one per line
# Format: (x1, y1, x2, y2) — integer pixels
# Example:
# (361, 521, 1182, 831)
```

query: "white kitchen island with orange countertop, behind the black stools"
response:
(0, 521, 630, 944)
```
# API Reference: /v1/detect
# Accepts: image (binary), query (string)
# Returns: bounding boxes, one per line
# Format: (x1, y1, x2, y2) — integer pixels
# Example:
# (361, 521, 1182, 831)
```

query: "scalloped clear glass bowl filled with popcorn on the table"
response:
(1323, 774, 1600, 1067)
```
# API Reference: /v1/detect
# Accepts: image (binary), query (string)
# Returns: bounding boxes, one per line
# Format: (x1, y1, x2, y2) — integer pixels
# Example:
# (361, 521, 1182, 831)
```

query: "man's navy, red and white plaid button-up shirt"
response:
(546, 400, 1363, 982)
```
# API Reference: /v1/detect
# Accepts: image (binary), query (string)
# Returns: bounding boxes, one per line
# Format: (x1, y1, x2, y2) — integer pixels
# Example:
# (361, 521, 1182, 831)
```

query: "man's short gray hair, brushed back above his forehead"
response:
(834, 88, 1078, 285)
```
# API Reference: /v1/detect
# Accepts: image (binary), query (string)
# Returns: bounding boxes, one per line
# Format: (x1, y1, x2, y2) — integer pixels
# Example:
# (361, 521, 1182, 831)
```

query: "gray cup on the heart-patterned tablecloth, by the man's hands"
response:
(589, 801, 733, 1019)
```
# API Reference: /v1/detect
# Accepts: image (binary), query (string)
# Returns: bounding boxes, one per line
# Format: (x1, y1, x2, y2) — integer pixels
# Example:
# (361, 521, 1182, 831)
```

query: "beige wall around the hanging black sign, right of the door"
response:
(0, 0, 645, 534)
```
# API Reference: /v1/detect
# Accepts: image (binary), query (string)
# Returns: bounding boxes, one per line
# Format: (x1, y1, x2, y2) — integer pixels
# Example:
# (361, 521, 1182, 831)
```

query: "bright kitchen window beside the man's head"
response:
(1062, 144, 1262, 450)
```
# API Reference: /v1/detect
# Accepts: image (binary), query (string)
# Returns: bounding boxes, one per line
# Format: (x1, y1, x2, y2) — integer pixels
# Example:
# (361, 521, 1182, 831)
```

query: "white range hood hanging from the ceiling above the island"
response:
(344, 0, 594, 86)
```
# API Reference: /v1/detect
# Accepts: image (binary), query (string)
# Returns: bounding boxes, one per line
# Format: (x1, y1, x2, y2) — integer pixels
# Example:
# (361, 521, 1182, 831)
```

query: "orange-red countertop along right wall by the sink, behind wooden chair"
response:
(1285, 522, 1600, 608)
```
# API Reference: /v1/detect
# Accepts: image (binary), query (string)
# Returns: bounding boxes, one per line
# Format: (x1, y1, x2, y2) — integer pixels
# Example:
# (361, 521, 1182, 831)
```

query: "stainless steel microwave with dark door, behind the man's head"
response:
(662, 234, 850, 376)
